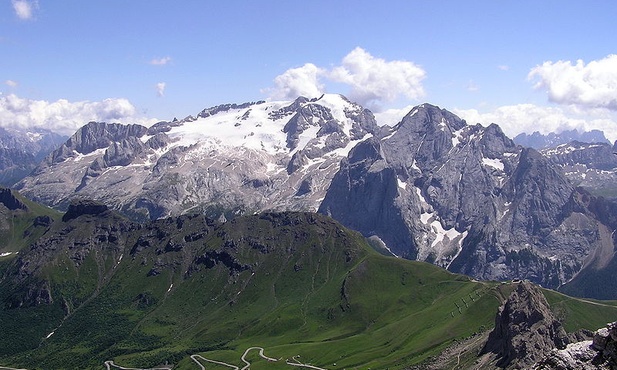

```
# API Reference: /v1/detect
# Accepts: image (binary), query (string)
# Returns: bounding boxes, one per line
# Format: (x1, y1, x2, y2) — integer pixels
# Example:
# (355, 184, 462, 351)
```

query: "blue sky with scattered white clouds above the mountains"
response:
(0, 0, 617, 140)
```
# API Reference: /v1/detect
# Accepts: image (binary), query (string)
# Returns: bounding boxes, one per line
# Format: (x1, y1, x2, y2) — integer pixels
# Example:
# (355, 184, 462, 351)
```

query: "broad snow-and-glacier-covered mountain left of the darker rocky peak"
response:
(18, 95, 378, 219)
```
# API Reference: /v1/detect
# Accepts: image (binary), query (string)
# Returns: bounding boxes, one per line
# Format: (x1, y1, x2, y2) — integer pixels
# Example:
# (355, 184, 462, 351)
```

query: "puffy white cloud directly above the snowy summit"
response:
(264, 47, 426, 110)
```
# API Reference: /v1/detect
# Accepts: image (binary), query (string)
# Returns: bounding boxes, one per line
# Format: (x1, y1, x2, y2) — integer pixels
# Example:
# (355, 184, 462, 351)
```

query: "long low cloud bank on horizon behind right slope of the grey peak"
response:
(453, 104, 617, 141)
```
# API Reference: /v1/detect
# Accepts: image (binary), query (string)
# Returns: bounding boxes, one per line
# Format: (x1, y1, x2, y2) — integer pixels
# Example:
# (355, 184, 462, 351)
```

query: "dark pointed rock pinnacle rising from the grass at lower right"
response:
(481, 281, 569, 369)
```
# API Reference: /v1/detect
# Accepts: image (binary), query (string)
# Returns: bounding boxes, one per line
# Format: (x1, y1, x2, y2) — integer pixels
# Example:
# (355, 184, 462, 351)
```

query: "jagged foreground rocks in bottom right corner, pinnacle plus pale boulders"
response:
(475, 281, 617, 370)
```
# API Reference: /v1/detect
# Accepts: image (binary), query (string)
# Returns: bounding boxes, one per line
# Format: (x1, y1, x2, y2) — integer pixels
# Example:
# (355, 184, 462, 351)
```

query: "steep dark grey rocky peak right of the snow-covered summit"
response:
(320, 104, 612, 287)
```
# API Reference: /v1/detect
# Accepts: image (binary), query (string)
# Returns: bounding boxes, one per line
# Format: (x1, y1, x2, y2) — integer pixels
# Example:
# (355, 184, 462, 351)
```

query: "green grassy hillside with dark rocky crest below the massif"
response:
(0, 212, 617, 370)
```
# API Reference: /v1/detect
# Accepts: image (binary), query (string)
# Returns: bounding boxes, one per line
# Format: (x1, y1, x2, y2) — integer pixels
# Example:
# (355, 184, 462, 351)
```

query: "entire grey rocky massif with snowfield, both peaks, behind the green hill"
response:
(13, 95, 615, 294)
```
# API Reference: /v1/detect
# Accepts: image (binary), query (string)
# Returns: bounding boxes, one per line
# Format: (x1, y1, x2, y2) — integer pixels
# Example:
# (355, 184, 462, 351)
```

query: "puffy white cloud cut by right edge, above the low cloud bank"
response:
(528, 55, 617, 111)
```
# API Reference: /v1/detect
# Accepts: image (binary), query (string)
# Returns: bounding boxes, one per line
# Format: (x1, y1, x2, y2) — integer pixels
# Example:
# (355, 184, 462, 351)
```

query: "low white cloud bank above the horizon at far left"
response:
(0, 94, 155, 135)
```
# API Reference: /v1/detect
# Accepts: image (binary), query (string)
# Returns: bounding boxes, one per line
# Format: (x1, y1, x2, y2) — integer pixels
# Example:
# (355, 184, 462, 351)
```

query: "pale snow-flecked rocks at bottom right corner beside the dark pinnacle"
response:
(533, 322, 617, 370)
